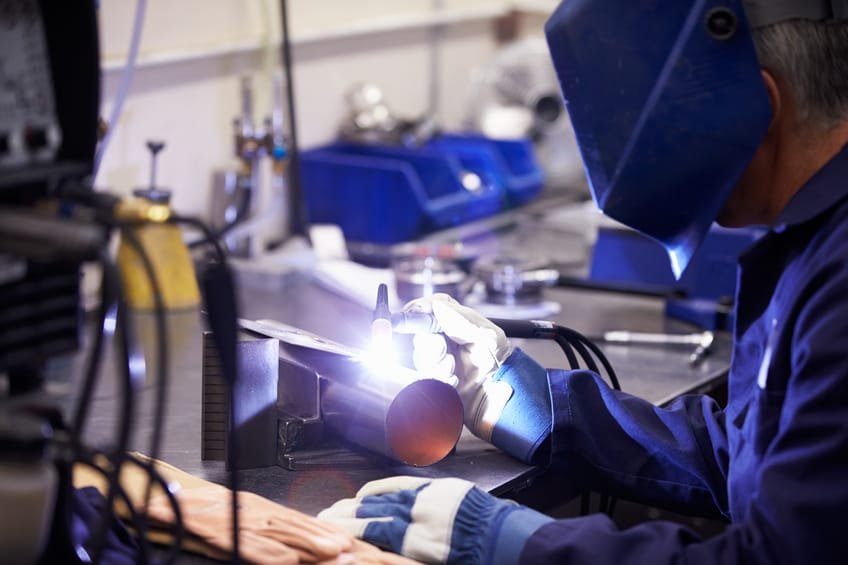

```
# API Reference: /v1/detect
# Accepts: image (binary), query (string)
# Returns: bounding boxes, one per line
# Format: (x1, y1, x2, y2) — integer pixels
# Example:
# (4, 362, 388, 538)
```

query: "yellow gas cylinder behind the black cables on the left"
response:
(118, 189, 200, 310)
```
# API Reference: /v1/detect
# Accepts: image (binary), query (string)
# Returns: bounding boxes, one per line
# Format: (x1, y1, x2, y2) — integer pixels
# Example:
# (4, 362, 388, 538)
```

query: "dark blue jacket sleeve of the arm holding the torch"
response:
(548, 370, 728, 517)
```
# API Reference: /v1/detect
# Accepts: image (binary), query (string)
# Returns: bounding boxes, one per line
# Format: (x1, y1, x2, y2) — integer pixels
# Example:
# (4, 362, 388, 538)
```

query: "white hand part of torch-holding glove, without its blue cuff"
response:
(404, 294, 514, 442)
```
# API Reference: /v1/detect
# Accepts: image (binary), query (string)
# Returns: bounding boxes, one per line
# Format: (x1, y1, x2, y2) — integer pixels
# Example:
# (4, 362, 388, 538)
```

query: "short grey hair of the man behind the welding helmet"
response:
(753, 19, 848, 129)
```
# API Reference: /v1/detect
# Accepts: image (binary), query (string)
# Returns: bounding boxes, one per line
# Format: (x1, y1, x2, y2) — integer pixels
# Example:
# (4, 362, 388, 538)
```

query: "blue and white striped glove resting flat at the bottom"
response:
(318, 477, 552, 565)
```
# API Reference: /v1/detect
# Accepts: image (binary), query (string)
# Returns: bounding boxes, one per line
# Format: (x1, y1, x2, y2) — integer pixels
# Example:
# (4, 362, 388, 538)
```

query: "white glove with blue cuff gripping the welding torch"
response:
(404, 294, 553, 463)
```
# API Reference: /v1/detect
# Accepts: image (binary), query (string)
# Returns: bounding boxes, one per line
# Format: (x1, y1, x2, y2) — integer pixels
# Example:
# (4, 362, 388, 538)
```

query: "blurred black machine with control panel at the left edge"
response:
(0, 0, 98, 391)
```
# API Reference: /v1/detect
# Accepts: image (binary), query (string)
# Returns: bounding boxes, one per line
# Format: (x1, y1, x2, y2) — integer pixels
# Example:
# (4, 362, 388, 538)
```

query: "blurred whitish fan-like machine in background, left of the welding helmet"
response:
(465, 37, 586, 195)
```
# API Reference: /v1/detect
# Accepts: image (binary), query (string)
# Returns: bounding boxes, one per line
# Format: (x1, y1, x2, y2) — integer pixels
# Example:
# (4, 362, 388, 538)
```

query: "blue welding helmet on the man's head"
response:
(545, 0, 848, 277)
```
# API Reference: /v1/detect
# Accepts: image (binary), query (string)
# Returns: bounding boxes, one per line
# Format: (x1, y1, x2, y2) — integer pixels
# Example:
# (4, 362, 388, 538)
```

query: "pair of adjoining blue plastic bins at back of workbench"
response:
(301, 135, 544, 244)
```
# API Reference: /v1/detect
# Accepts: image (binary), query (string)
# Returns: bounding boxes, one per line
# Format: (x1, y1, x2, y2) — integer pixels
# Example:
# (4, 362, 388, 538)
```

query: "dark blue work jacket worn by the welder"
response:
(521, 143, 848, 565)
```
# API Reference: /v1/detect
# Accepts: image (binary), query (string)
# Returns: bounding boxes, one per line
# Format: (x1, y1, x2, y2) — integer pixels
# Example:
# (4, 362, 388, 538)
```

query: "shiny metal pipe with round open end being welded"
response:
(321, 374, 462, 466)
